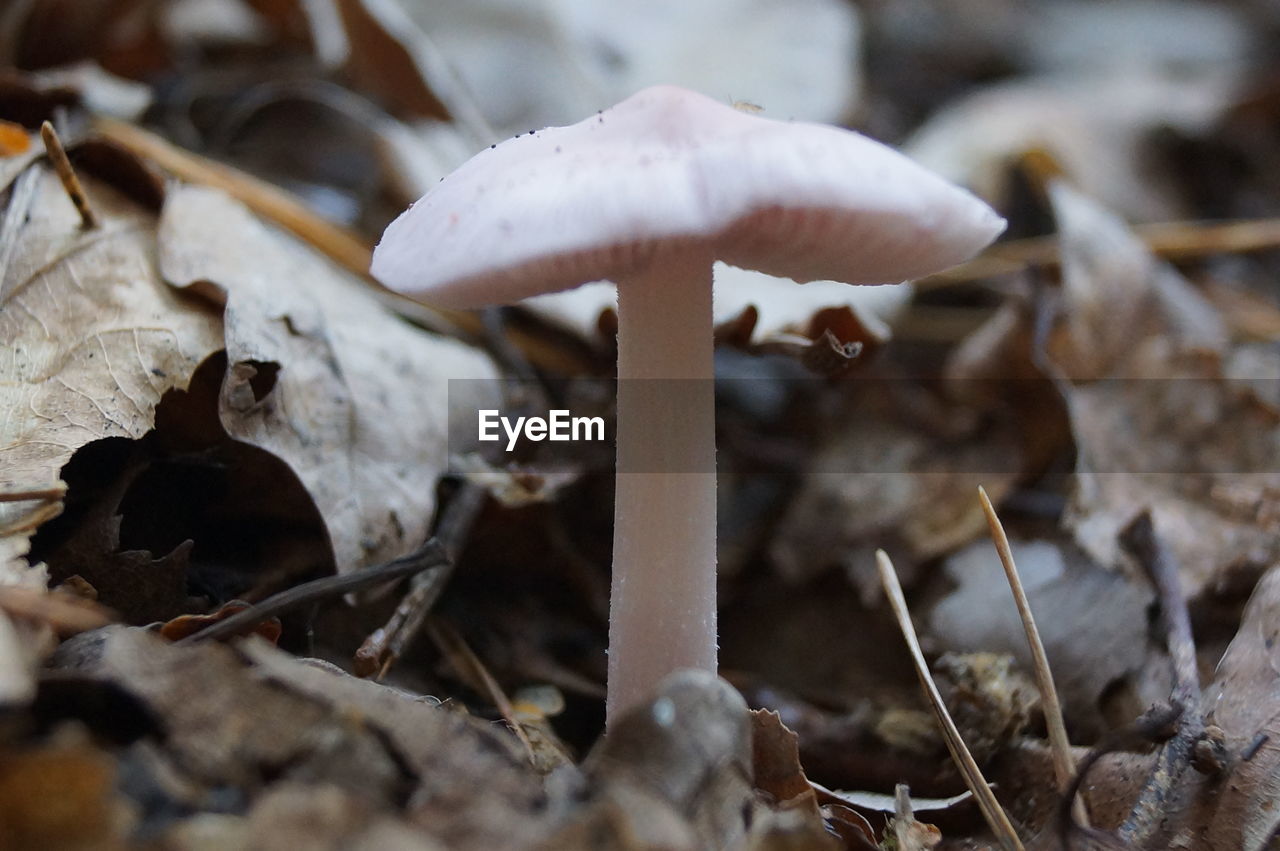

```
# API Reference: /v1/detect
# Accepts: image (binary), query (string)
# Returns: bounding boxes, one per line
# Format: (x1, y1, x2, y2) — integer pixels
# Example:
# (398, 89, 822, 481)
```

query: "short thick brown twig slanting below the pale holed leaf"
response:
(353, 482, 485, 680)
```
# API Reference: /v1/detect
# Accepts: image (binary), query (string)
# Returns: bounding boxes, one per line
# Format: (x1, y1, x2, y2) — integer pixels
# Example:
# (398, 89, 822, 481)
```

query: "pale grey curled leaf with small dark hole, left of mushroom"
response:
(159, 187, 497, 571)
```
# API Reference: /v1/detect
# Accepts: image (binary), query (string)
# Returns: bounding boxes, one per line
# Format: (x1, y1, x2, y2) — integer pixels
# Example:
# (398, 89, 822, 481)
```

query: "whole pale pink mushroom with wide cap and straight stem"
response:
(372, 86, 1005, 723)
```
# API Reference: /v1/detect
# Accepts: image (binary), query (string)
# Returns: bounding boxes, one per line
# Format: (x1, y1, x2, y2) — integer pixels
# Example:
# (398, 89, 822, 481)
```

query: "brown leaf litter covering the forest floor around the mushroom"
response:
(0, 0, 1280, 851)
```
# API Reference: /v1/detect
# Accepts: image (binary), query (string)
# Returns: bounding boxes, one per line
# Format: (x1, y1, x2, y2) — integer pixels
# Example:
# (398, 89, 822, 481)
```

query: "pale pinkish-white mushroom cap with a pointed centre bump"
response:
(372, 86, 1005, 307)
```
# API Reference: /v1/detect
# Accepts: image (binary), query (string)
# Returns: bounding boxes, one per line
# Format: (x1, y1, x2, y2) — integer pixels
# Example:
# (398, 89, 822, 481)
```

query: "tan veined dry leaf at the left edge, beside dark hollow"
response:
(0, 159, 223, 570)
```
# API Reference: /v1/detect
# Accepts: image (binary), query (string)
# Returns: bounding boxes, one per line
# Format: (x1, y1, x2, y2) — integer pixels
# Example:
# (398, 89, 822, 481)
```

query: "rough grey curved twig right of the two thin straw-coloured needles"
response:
(1116, 509, 1204, 845)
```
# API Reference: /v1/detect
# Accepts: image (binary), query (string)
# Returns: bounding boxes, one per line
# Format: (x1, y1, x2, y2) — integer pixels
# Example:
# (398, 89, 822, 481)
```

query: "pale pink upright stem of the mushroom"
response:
(605, 247, 716, 726)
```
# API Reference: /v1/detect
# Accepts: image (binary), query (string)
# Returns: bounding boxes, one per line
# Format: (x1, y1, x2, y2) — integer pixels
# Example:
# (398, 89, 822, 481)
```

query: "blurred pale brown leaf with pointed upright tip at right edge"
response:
(1048, 184, 1280, 598)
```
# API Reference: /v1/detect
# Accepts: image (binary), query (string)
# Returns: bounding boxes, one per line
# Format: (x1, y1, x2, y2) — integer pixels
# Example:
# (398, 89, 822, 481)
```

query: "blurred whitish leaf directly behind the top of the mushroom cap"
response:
(391, 0, 860, 136)
